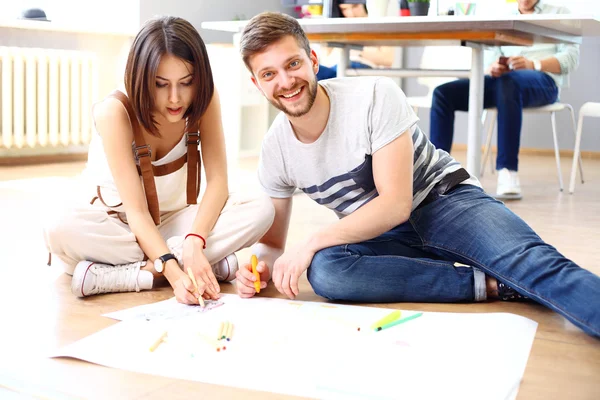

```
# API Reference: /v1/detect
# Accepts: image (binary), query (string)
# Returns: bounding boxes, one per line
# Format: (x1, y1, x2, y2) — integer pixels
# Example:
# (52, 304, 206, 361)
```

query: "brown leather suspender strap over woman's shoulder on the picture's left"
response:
(110, 90, 160, 225)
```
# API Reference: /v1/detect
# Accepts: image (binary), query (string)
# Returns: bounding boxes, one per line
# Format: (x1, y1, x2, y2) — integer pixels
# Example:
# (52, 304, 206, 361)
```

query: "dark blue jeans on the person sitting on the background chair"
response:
(430, 70, 558, 171)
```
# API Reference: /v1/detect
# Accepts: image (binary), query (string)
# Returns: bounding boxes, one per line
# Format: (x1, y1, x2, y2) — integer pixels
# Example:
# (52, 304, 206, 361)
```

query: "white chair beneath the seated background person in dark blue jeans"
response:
(481, 102, 583, 192)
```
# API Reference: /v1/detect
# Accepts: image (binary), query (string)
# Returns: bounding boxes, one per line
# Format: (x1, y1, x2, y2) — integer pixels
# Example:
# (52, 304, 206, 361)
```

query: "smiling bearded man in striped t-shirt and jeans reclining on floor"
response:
(237, 13, 600, 336)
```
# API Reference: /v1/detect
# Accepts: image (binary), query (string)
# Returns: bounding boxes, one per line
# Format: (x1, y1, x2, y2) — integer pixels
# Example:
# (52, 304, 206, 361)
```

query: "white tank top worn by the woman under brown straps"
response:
(82, 129, 195, 215)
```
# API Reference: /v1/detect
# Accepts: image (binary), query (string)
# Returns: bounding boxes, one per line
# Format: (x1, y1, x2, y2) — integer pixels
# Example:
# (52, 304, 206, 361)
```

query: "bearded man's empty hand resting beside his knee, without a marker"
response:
(273, 245, 315, 299)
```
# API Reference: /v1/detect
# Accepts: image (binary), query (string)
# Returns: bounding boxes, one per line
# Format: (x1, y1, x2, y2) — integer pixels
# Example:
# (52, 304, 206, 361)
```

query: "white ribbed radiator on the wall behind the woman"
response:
(0, 47, 98, 156)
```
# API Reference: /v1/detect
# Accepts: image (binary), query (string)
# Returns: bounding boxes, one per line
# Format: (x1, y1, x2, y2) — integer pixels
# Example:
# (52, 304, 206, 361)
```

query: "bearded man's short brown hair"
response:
(240, 12, 310, 72)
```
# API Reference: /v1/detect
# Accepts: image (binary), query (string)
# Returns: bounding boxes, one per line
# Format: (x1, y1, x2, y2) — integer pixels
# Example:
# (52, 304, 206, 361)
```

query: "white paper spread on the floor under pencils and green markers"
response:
(53, 295, 537, 400)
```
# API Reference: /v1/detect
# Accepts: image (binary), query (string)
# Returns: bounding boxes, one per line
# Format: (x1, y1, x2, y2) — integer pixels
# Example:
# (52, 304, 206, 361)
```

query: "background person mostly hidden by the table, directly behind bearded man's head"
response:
(317, 0, 394, 81)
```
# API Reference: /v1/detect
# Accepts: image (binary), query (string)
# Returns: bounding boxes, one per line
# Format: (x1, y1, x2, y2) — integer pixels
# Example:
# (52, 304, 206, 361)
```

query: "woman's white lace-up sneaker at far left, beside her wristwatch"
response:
(71, 261, 153, 297)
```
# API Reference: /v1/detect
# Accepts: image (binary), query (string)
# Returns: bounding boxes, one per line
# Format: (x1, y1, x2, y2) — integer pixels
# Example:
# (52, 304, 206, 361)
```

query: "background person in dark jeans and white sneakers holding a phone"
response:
(430, 0, 579, 199)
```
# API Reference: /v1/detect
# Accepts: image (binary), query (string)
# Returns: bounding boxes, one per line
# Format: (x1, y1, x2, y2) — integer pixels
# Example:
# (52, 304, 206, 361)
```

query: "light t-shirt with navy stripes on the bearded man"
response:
(258, 77, 480, 217)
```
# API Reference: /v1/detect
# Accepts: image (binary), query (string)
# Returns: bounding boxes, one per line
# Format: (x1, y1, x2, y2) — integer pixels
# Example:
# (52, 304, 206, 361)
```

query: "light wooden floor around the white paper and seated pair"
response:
(0, 153, 600, 400)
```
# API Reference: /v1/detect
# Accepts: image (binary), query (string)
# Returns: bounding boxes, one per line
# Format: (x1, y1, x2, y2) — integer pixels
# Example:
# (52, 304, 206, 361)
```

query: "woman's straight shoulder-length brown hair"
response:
(125, 17, 215, 136)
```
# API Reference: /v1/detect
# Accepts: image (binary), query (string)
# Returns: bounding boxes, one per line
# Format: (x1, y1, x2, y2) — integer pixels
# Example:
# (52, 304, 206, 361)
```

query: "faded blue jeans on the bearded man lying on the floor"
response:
(307, 185, 600, 337)
